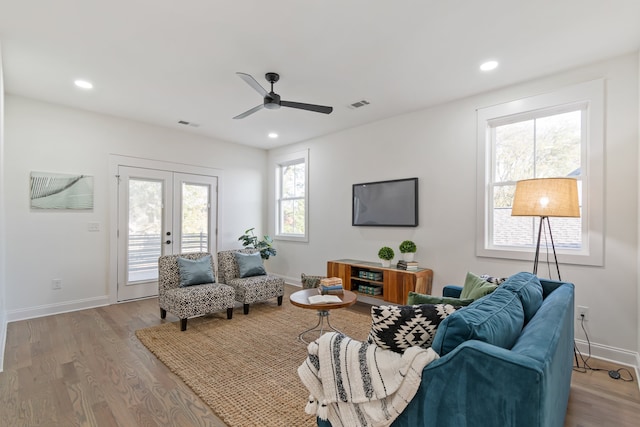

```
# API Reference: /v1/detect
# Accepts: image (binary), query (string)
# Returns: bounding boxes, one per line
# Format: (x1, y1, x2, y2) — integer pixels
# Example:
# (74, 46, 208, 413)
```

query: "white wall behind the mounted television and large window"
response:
(269, 54, 640, 364)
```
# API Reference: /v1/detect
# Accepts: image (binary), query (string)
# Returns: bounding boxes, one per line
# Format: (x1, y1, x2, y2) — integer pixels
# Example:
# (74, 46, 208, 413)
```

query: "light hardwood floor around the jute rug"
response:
(0, 290, 640, 427)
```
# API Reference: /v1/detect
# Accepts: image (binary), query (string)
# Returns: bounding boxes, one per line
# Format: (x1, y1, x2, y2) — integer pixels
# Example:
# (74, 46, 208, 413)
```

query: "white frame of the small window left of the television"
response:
(274, 150, 309, 242)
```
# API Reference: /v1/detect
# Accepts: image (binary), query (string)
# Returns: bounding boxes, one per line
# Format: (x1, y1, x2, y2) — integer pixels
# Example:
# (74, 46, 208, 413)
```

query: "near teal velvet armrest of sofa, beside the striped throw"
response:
(392, 341, 548, 427)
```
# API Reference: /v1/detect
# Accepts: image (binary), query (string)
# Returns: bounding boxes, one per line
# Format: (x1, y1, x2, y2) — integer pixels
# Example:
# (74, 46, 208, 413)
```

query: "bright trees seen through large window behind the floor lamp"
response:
(490, 106, 584, 249)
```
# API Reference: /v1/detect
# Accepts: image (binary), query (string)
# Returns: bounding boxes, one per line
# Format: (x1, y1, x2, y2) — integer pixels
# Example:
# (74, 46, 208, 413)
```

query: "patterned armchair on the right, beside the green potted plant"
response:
(218, 249, 284, 314)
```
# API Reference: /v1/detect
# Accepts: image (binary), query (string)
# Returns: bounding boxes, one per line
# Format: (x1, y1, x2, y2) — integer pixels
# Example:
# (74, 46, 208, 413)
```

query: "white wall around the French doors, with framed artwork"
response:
(3, 94, 267, 321)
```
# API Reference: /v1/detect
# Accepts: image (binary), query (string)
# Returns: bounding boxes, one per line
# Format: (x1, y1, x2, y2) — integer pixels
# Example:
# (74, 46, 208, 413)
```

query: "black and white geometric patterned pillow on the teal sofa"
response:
(367, 304, 459, 353)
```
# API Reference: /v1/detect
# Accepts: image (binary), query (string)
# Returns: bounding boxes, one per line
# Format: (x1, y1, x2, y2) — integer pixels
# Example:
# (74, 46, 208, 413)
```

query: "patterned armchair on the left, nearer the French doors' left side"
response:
(158, 252, 235, 331)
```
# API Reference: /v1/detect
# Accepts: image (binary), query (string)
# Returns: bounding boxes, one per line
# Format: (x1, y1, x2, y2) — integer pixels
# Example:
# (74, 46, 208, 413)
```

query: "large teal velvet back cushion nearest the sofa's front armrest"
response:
(432, 288, 524, 356)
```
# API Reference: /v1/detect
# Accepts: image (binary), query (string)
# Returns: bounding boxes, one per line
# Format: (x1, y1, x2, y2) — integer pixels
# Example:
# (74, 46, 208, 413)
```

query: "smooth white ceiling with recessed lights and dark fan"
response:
(0, 0, 640, 148)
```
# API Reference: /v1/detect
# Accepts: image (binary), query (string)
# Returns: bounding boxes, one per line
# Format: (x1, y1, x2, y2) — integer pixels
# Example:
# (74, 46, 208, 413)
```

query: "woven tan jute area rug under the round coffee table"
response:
(136, 292, 371, 427)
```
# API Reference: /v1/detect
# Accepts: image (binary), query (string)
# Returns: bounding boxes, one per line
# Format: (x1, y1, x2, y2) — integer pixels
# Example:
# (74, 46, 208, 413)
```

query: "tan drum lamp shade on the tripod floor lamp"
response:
(511, 178, 580, 217)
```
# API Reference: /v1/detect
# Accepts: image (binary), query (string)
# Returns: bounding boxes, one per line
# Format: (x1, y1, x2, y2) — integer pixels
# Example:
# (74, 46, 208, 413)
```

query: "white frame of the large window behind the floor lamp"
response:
(476, 79, 605, 266)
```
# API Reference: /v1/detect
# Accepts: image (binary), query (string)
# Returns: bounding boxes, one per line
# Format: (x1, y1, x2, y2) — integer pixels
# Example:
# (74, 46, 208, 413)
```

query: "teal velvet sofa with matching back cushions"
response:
(318, 273, 574, 427)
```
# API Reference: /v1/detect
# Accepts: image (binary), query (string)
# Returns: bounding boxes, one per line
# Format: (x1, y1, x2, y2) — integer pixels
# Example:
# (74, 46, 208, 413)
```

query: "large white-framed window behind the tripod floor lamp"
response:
(477, 80, 604, 265)
